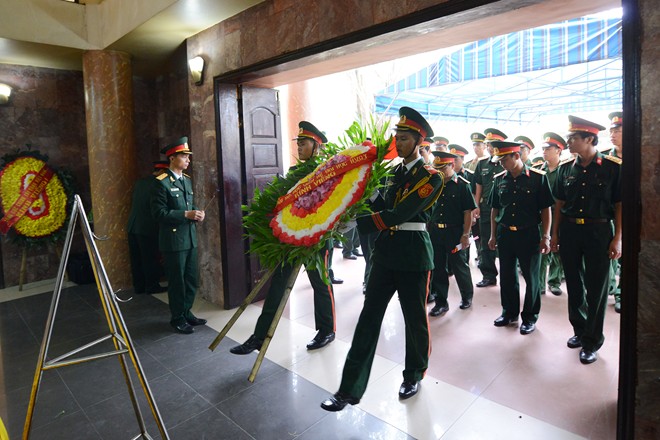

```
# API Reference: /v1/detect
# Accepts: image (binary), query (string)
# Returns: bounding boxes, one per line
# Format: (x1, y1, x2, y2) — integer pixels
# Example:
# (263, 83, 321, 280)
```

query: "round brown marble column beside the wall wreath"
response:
(82, 50, 137, 288)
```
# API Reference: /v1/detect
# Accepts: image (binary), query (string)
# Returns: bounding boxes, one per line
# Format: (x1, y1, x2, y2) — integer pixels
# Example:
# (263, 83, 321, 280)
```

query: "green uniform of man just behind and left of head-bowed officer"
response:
(474, 143, 502, 282)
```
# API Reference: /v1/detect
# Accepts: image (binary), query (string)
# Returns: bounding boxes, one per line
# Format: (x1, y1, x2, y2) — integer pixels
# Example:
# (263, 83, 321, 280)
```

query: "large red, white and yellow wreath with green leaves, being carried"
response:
(243, 119, 391, 270)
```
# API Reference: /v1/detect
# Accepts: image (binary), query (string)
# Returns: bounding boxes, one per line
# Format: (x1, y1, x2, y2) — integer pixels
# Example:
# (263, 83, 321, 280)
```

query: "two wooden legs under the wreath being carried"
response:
(209, 263, 302, 382)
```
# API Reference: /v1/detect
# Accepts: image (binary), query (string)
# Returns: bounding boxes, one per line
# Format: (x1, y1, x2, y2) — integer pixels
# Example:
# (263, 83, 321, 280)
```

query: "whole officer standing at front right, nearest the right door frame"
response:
(551, 116, 621, 364)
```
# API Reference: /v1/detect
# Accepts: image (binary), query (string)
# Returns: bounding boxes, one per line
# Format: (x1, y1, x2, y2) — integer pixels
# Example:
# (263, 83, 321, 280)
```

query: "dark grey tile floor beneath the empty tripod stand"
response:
(0, 285, 411, 440)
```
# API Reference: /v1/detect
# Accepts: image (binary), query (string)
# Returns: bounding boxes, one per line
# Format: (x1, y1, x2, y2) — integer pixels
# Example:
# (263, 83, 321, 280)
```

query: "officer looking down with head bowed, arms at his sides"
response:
(488, 141, 555, 335)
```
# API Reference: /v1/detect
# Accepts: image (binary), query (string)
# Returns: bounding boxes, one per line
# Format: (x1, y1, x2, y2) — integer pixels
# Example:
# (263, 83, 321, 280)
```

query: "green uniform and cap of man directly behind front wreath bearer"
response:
(429, 153, 477, 307)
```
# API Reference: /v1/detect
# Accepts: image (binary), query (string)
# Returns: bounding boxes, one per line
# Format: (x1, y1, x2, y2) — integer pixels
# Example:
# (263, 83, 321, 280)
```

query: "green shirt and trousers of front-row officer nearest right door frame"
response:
(555, 135, 621, 352)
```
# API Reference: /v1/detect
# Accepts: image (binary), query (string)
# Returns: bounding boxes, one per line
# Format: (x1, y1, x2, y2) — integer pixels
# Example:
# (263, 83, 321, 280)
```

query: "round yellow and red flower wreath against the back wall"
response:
(0, 150, 73, 246)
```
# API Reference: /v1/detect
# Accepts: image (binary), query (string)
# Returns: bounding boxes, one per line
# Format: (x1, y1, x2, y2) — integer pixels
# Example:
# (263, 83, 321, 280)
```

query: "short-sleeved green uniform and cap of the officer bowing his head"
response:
(490, 142, 554, 324)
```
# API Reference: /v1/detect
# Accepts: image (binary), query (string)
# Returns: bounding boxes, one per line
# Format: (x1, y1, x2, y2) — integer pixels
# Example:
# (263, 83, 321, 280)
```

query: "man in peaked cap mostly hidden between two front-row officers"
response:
(537, 132, 566, 296)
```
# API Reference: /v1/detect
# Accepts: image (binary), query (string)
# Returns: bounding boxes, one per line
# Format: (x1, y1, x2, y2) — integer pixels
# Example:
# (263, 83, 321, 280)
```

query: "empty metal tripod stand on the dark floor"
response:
(23, 194, 169, 440)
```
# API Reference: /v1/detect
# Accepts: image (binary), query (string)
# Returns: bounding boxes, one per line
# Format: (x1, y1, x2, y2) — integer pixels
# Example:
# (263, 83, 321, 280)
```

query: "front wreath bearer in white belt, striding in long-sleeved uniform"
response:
(321, 107, 442, 411)
